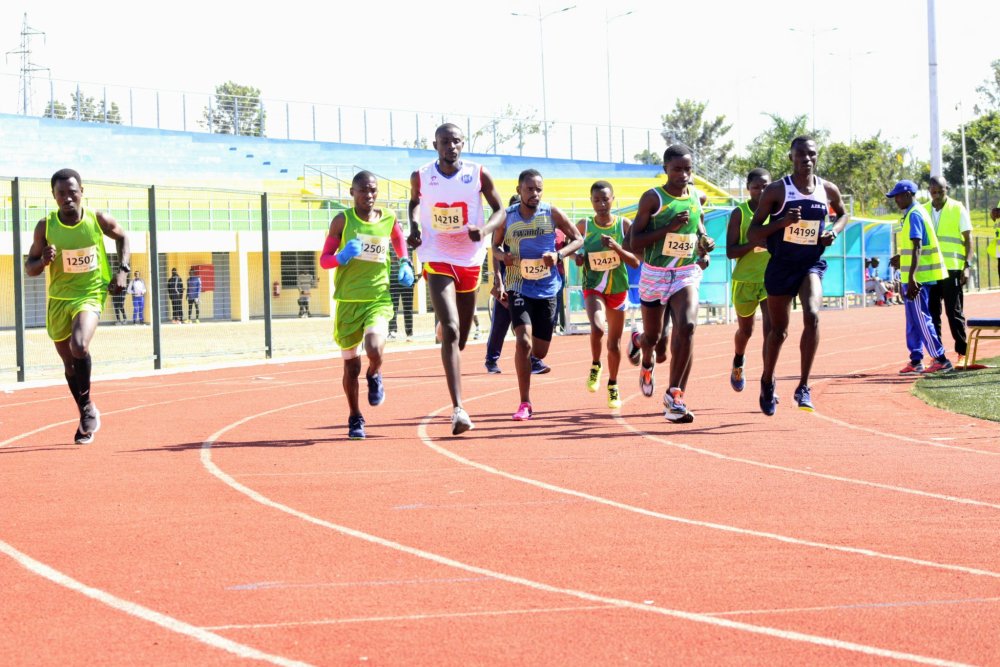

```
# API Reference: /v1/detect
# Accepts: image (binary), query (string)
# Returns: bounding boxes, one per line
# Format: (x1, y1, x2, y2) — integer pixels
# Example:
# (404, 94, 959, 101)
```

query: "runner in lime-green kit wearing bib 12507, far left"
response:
(24, 169, 132, 445)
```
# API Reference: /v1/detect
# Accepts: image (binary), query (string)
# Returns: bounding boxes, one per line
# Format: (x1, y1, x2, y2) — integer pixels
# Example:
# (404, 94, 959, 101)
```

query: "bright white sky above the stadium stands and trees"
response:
(0, 0, 1000, 166)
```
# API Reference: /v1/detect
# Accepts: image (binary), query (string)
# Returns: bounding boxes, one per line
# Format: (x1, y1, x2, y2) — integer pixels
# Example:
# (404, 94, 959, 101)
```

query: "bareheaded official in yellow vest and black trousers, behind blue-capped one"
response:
(924, 176, 972, 364)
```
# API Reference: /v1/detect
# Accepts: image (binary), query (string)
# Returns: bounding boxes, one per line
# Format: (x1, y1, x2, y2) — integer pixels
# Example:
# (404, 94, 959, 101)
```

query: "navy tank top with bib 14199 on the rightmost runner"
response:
(767, 176, 829, 265)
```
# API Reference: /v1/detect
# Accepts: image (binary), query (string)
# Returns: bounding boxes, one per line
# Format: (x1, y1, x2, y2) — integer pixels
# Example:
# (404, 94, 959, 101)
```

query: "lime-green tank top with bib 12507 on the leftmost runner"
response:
(45, 209, 111, 301)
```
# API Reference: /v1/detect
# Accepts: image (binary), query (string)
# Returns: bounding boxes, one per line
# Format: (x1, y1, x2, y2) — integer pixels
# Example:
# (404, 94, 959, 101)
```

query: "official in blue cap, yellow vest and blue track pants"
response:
(886, 180, 954, 375)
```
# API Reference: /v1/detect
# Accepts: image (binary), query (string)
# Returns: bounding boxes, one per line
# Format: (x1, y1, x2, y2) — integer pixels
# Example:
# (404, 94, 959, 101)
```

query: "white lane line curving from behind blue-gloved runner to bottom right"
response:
(201, 412, 964, 666)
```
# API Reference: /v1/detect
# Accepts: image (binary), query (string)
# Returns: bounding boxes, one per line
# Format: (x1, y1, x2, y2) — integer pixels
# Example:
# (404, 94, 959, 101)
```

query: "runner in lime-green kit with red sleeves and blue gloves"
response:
(319, 171, 413, 440)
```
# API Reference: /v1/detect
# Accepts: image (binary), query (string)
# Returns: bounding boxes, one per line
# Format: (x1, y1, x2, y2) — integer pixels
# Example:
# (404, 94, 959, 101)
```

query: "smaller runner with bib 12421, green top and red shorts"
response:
(574, 181, 639, 410)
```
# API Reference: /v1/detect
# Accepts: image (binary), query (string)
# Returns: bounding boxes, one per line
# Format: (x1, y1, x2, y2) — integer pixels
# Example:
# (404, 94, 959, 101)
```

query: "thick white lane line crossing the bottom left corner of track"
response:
(0, 540, 308, 667)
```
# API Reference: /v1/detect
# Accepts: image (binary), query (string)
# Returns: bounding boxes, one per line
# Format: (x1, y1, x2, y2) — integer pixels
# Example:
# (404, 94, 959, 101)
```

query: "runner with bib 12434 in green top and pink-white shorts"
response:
(629, 144, 715, 423)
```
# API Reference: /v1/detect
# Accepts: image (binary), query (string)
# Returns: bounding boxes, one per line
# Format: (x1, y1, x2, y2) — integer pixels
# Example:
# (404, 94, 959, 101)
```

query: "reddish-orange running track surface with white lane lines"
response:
(0, 294, 1000, 665)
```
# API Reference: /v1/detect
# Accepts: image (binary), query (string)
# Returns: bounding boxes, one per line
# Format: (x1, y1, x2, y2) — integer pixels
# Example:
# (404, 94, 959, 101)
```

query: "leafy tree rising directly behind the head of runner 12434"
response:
(660, 100, 733, 180)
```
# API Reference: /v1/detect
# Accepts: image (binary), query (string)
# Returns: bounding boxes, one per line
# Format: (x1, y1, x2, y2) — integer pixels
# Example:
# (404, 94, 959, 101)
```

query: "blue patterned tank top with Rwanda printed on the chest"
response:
(504, 202, 562, 299)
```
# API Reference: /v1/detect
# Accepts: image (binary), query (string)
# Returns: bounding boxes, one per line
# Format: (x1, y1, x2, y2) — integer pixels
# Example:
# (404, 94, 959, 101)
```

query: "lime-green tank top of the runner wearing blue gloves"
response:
(333, 208, 396, 301)
